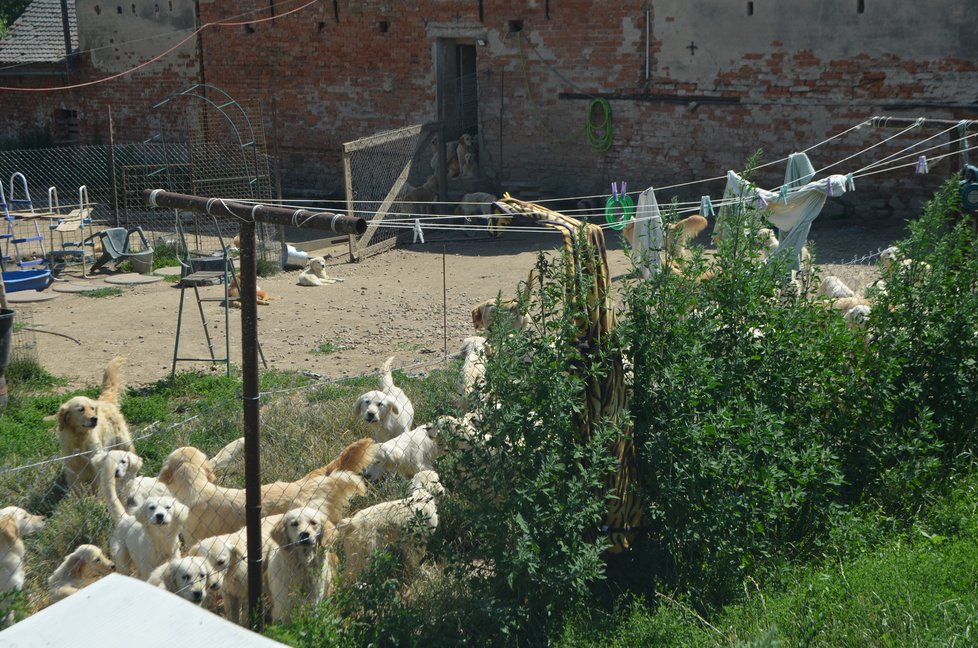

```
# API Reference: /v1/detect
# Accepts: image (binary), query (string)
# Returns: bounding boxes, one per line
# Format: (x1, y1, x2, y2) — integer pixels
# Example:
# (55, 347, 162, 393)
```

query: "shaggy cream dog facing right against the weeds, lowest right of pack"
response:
(336, 470, 445, 579)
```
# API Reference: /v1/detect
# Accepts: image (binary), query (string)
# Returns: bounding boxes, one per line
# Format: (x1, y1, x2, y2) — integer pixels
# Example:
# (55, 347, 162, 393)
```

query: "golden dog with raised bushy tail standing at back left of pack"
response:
(58, 357, 133, 495)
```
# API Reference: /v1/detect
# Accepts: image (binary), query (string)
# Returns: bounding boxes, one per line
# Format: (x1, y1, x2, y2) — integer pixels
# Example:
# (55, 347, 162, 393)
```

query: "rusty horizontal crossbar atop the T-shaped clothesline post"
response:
(143, 189, 367, 235)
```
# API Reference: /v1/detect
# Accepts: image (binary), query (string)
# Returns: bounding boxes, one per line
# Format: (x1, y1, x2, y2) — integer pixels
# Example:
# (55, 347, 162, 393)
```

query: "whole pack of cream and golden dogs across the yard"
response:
(0, 205, 916, 625)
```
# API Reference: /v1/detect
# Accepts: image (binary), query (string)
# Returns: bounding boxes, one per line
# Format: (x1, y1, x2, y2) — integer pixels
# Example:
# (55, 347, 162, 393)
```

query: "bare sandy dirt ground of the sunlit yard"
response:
(12, 215, 904, 389)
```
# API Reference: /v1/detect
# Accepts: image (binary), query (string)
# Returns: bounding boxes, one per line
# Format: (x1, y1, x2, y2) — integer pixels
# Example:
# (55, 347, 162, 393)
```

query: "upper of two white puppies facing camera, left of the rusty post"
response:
(109, 497, 190, 580)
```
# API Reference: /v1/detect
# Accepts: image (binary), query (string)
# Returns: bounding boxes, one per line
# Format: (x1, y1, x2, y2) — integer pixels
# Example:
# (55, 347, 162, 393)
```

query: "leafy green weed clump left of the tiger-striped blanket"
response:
(443, 247, 621, 632)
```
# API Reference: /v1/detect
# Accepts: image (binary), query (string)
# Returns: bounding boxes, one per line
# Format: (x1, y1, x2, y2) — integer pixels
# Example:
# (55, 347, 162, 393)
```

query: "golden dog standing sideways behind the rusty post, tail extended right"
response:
(159, 446, 366, 545)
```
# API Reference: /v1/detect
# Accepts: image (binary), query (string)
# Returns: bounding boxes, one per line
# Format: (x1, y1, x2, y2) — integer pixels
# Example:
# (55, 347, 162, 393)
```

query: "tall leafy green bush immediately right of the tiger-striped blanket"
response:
(622, 175, 862, 605)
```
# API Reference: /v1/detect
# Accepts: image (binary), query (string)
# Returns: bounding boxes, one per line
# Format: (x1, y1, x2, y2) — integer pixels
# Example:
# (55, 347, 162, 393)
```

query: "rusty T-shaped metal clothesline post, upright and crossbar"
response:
(143, 189, 367, 631)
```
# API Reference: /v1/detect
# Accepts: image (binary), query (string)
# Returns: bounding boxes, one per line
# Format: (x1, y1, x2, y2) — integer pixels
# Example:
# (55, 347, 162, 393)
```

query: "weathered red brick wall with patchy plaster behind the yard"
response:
(0, 0, 978, 216)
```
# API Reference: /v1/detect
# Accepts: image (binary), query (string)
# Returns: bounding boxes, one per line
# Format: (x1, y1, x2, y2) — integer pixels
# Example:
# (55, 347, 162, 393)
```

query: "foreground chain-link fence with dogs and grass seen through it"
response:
(0, 354, 460, 625)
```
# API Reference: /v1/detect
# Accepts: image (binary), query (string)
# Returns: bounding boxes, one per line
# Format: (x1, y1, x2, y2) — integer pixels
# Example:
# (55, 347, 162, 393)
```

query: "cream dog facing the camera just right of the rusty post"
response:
(268, 507, 337, 623)
